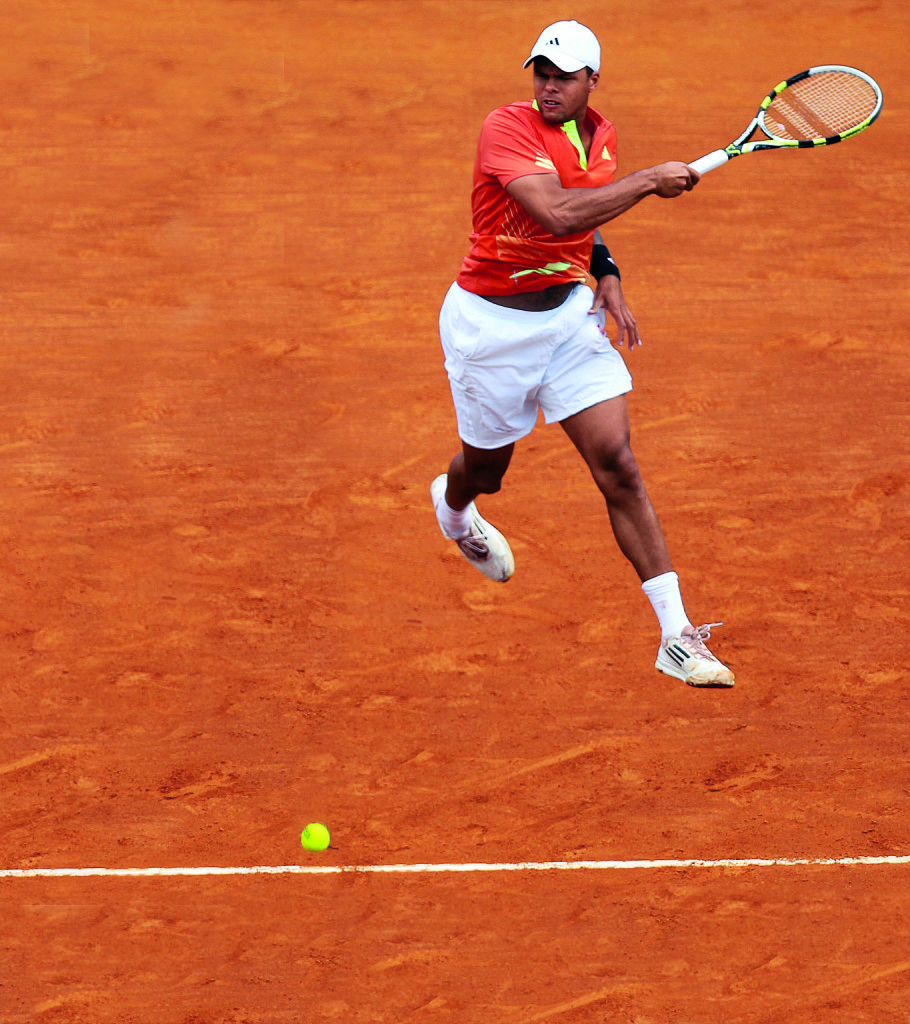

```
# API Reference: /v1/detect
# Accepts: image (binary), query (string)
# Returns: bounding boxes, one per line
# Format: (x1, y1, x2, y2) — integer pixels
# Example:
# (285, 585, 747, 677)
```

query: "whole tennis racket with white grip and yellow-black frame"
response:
(689, 65, 882, 174)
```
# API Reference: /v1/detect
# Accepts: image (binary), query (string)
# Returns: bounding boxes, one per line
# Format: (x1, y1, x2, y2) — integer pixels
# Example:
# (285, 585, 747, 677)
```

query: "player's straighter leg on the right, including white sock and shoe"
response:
(562, 395, 734, 686)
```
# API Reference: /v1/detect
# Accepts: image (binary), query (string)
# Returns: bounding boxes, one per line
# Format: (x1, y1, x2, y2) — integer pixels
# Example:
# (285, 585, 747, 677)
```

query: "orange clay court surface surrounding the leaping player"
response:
(0, 0, 910, 1024)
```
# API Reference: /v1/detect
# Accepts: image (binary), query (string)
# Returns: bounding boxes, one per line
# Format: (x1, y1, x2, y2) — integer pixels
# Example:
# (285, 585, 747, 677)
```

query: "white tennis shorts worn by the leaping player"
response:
(439, 285, 632, 449)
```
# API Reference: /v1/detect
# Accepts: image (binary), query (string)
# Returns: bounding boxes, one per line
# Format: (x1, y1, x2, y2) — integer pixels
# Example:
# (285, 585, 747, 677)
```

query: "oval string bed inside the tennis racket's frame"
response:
(764, 71, 878, 140)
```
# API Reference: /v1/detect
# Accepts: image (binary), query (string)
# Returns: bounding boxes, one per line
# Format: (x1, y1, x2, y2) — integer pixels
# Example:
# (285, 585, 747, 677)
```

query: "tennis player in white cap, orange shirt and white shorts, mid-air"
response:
(431, 22, 733, 686)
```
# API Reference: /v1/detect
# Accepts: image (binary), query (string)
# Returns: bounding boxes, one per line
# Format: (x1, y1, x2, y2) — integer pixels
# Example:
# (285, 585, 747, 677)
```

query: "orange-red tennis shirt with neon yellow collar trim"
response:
(456, 100, 616, 295)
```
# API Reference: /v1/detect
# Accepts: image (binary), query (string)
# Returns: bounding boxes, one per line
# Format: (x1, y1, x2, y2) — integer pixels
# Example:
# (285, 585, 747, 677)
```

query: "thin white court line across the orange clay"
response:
(0, 856, 910, 879)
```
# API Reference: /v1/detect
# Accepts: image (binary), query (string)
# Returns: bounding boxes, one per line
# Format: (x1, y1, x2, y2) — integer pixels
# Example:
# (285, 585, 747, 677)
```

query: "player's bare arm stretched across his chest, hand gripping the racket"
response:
(506, 161, 699, 237)
